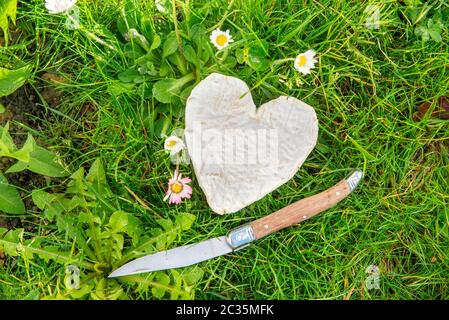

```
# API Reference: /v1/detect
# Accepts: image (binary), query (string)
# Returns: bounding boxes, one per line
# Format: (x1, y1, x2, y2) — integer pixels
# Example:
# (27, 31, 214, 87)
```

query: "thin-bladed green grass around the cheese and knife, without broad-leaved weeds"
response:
(0, 0, 449, 299)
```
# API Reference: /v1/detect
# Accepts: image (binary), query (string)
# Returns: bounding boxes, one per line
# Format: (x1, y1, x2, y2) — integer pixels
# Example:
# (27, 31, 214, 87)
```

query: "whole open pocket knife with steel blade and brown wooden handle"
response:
(109, 170, 363, 278)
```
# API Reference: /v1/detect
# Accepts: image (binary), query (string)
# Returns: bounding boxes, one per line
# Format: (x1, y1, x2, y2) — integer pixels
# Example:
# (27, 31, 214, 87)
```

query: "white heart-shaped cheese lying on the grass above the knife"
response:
(185, 73, 318, 214)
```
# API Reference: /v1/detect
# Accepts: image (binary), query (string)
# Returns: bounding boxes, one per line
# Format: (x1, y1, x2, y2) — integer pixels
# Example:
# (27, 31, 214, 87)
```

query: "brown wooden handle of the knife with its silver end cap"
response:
(250, 170, 362, 239)
